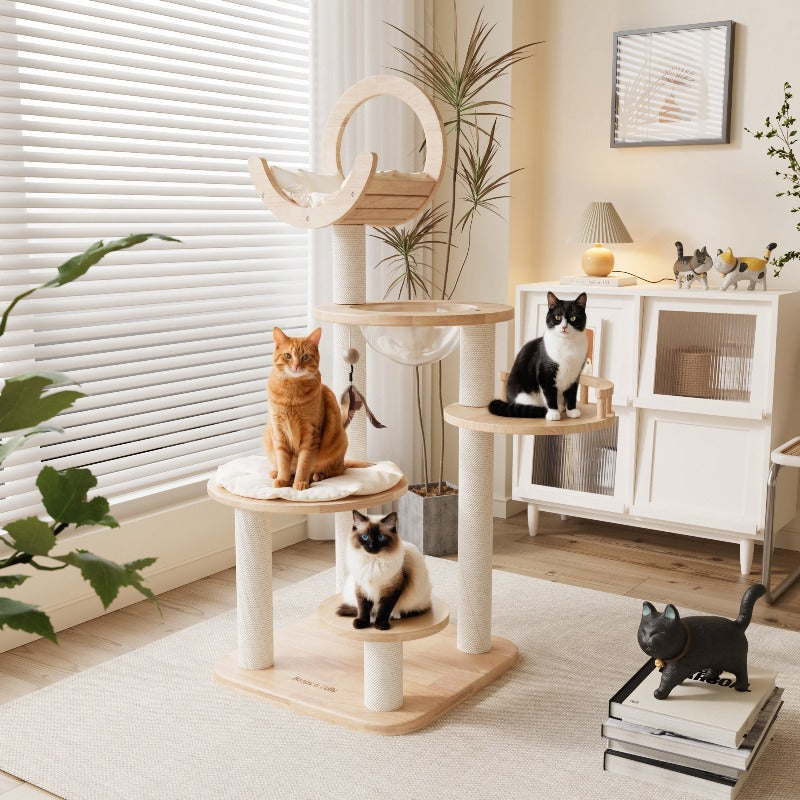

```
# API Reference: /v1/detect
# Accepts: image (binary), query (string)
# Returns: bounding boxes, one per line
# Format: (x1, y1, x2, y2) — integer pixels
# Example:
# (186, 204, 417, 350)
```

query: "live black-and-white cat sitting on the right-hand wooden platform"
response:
(489, 292, 588, 420)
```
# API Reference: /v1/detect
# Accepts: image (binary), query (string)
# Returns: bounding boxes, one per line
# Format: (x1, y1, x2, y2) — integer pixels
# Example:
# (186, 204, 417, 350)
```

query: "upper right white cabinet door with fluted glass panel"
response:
(635, 291, 774, 419)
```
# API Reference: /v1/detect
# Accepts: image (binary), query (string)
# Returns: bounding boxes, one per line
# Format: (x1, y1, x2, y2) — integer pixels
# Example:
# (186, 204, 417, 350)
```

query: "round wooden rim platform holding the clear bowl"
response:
(313, 300, 514, 328)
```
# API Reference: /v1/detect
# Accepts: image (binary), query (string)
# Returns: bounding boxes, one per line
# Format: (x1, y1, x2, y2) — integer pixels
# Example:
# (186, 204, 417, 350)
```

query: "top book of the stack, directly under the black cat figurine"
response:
(608, 659, 776, 747)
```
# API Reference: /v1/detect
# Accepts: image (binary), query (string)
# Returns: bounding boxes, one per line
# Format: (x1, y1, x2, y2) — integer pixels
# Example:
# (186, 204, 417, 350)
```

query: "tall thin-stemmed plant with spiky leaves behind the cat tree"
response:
(377, 3, 539, 494)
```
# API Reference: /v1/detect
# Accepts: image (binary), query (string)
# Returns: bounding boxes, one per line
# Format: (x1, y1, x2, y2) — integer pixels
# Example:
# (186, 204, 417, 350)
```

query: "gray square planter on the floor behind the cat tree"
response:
(397, 483, 458, 556)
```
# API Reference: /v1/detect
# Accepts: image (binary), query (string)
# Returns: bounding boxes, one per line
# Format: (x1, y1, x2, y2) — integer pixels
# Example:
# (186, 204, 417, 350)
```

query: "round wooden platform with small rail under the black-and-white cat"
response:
(444, 403, 616, 436)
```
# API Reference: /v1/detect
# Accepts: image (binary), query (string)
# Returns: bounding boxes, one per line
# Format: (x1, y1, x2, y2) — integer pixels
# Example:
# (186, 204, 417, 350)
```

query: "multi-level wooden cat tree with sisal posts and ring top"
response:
(209, 76, 613, 734)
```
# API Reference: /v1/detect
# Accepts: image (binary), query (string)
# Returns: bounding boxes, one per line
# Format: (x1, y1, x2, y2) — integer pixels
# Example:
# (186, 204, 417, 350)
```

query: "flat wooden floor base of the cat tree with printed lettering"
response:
(214, 598, 518, 736)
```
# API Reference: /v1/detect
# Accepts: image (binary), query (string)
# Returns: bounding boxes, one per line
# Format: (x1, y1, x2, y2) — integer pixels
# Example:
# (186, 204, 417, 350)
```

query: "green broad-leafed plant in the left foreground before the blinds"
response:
(0, 233, 178, 642)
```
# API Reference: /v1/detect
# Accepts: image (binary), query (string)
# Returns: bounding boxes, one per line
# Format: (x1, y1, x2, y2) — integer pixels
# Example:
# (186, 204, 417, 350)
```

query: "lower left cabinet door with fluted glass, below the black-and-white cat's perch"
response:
(514, 409, 636, 513)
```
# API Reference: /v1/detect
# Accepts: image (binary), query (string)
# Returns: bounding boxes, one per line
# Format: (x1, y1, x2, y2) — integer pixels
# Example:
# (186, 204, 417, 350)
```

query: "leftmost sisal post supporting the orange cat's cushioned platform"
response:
(235, 508, 275, 669)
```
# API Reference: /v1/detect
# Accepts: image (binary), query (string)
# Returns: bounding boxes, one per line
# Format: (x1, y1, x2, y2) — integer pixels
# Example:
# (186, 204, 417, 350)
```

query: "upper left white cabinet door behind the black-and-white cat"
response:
(515, 286, 639, 407)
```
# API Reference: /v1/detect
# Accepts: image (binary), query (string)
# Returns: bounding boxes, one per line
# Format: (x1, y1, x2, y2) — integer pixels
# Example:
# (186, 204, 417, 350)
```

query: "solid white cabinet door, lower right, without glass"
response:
(631, 410, 769, 536)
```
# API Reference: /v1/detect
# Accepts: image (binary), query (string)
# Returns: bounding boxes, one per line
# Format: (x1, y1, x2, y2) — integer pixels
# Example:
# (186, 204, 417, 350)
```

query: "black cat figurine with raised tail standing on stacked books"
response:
(638, 583, 767, 700)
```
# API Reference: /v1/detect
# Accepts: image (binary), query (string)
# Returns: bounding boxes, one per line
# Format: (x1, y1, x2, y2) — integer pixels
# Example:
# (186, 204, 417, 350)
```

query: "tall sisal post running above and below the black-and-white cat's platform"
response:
(458, 324, 494, 653)
